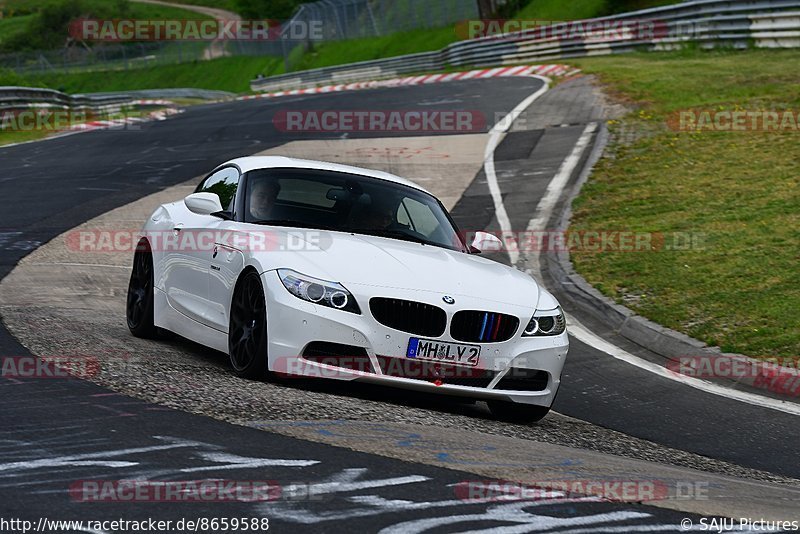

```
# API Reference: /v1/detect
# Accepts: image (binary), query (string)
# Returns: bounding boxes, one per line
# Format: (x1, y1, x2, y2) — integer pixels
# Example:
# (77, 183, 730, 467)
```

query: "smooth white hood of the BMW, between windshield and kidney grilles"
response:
(253, 230, 540, 308)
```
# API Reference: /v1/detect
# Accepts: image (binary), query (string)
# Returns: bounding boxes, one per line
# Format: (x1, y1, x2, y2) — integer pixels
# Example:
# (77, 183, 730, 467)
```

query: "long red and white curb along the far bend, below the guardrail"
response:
(237, 65, 580, 100)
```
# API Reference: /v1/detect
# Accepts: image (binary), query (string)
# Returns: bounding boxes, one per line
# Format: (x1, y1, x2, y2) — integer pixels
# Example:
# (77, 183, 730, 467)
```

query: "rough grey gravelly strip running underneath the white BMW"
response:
(3, 306, 800, 487)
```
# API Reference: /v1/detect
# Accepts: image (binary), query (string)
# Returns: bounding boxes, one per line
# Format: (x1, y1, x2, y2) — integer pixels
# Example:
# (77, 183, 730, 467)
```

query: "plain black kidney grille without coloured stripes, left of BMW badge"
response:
(369, 297, 447, 337)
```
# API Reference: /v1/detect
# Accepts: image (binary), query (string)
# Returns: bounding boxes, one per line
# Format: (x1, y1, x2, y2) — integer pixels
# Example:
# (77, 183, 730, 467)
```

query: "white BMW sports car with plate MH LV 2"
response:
(127, 157, 569, 421)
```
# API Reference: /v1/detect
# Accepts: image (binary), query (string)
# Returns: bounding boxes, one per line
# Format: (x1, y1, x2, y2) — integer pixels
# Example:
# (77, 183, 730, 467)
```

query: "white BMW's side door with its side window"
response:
(162, 167, 239, 328)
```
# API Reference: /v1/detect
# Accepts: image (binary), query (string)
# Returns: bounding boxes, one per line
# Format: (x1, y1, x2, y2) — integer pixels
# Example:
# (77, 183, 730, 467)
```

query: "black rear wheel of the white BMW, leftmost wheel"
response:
(125, 240, 159, 339)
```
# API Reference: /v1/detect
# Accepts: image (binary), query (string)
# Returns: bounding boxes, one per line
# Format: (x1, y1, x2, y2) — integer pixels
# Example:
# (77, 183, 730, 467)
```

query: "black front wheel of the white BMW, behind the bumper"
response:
(228, 271, 267, 380)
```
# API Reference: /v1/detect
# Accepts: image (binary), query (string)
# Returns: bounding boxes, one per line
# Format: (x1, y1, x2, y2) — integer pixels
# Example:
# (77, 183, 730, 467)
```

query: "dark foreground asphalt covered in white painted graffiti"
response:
(0, 381, 708, 532)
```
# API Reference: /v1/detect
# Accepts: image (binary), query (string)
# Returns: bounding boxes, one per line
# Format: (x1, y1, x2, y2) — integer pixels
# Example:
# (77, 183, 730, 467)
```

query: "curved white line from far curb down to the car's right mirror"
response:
(483, 75, 550, 265)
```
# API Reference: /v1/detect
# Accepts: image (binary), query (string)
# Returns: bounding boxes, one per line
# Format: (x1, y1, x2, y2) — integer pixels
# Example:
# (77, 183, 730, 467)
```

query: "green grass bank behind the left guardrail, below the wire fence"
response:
(26, 56, 282, 93)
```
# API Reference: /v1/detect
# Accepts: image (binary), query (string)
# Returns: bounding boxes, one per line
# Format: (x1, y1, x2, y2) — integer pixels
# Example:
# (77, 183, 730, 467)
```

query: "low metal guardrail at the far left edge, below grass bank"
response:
(0, 86, 235, 111)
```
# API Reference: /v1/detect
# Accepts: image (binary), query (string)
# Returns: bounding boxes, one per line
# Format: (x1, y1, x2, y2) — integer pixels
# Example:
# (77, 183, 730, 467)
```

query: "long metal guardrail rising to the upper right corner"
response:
(250, 0, 800, 92)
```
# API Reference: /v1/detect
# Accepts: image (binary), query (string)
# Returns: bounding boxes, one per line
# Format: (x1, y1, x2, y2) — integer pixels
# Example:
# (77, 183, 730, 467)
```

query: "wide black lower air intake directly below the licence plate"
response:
(376, 355, 496, 388)
